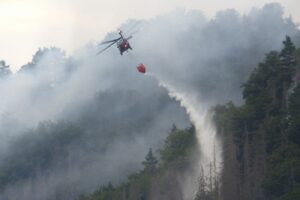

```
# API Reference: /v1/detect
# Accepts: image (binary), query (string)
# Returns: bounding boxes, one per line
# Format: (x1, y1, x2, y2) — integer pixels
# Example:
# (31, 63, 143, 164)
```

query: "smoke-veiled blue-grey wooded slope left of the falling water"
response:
(0, 86, 188, 199)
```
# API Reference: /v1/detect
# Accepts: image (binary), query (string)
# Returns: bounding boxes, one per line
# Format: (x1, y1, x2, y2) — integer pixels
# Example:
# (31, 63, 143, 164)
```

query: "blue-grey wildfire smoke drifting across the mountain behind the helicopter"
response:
(0, 4, 300, 200)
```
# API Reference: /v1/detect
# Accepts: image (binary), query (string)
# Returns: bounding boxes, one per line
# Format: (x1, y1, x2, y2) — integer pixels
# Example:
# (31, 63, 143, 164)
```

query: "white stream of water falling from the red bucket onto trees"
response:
(147, 73, 222, 199)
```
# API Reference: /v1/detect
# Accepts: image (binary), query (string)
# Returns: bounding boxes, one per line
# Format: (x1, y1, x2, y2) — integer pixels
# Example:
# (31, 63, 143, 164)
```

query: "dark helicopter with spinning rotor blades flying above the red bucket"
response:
(97, 30, 137, 55)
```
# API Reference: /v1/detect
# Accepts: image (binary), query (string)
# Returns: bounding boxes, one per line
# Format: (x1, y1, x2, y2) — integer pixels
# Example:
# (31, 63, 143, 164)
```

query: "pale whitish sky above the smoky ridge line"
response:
(0, 0, 300, 70)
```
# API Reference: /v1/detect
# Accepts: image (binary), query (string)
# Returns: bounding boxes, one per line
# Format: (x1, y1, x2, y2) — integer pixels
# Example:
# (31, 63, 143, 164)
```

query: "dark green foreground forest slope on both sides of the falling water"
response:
(81, 37, 300, 200)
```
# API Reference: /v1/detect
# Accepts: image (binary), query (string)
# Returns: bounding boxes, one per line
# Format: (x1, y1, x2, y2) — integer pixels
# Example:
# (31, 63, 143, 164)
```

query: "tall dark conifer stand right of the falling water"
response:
(215, 37, 300, 200)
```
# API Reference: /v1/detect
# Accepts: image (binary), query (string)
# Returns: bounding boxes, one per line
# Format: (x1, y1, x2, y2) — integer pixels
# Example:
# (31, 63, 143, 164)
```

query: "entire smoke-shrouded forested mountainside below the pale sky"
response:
(0, 3, 300, 200)
